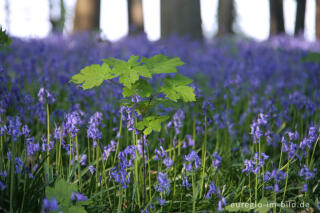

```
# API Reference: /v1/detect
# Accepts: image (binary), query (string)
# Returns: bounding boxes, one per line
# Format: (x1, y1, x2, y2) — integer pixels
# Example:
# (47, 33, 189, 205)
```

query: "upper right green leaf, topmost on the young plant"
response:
(141, 54, 184, 74)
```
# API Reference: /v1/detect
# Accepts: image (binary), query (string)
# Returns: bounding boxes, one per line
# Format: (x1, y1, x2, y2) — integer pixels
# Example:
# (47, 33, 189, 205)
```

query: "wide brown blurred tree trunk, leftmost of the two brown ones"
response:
(73, 0, 100, 32)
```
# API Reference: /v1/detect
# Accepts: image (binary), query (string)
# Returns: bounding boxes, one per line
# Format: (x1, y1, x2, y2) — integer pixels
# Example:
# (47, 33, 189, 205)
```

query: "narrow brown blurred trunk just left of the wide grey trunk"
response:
(128, 0, 144, 35)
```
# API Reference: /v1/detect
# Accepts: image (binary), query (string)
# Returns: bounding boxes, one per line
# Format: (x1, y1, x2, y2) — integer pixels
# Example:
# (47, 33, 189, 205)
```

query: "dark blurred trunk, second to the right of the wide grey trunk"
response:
(269, 0, 285, 36)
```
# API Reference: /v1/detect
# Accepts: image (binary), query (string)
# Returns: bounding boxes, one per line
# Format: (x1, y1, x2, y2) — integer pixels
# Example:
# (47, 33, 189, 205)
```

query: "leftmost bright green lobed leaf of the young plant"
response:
(71, 64, 113, 90)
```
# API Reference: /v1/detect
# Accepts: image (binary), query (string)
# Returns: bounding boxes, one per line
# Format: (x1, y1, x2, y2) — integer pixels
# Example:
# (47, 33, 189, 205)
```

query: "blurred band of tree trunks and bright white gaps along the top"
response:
(0, 0, 320, 41)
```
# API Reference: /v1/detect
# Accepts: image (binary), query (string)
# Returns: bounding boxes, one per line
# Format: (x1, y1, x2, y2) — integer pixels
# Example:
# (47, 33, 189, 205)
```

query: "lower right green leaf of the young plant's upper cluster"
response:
(160, 74, 196, 102)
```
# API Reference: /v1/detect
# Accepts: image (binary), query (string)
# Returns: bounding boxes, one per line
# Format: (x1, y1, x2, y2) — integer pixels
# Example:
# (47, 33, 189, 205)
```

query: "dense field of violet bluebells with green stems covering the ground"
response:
(0, 36, 320, 212)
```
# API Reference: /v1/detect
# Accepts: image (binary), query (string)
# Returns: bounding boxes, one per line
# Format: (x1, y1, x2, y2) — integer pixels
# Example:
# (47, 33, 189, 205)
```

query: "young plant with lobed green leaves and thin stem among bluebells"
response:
(71, 54, 196, 205)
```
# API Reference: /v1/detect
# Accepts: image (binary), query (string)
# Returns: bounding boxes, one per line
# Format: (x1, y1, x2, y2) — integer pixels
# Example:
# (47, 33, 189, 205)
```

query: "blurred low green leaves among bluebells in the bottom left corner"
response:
(46, 179, 89, 213)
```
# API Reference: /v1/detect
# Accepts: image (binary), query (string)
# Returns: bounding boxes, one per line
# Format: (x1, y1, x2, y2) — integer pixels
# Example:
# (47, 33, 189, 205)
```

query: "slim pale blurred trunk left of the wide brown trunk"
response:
(49, 0, 66, 33)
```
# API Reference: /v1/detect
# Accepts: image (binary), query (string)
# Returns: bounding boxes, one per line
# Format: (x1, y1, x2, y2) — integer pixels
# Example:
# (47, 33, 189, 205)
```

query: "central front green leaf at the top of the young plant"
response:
(103, 55, 152, 89)
